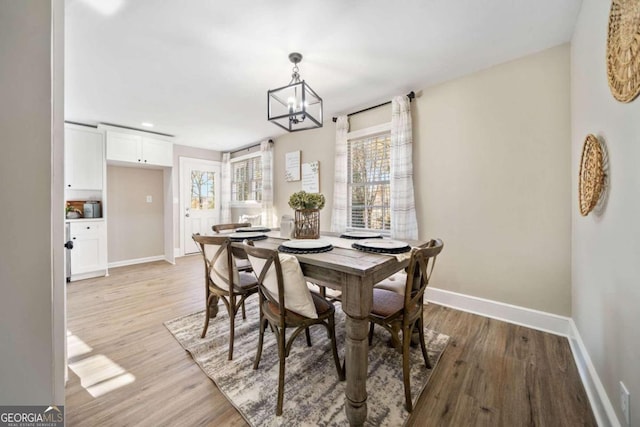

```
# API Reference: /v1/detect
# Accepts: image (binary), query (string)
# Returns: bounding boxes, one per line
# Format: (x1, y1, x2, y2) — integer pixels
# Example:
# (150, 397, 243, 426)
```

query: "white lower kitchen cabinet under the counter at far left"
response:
(69, 220, 107, 280)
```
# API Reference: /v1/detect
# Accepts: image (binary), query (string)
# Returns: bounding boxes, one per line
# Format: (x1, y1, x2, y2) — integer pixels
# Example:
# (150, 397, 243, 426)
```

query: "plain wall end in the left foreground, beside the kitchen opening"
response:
(0, 0, 64, 405)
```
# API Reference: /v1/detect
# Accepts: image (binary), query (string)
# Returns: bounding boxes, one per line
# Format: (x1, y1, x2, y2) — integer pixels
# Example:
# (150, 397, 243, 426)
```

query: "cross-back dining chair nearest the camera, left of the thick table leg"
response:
(243, 240, 344, 416)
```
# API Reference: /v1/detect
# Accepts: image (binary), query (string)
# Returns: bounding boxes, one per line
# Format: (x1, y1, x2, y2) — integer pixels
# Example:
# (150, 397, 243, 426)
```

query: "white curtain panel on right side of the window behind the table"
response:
(390, 96, 418, 239)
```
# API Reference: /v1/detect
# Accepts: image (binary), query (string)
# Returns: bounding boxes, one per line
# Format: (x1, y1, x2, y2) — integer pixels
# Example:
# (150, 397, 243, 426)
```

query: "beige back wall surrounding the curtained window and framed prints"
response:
(274, 44, 571, 316)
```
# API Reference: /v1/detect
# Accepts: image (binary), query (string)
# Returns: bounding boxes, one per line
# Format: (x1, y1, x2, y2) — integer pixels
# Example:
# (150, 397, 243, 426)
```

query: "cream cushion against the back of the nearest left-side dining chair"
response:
(249, 254, 318, 319)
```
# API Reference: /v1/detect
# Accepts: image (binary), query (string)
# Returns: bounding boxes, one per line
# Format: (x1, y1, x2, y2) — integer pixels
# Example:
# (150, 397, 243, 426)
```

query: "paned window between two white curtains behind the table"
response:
(347, 133, 391, 232)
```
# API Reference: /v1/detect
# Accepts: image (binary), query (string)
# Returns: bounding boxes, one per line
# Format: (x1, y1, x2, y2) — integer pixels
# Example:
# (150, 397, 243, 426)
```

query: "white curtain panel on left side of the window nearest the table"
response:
(331, 116, 349, 233)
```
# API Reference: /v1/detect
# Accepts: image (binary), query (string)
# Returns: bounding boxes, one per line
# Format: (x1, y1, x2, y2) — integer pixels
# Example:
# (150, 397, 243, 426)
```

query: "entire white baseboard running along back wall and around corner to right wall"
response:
(425, 288, 620, 427)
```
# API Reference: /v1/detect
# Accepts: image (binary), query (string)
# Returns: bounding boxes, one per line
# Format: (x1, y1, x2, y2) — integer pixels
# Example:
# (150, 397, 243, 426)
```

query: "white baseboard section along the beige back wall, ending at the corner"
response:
(425, 287, 571, 337)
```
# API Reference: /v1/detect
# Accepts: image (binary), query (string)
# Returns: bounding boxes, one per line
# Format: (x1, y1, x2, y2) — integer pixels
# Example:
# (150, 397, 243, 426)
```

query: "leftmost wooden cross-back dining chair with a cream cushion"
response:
(192, 234, 258, 360)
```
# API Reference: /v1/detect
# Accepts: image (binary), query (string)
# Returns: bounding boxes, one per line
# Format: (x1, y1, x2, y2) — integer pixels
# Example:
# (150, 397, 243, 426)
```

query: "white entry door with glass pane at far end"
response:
(180, 157, 220, 255)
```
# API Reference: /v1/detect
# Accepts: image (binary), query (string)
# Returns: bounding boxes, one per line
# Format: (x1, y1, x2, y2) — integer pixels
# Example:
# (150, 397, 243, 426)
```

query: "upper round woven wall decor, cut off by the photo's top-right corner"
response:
(607, 0, 640, 102)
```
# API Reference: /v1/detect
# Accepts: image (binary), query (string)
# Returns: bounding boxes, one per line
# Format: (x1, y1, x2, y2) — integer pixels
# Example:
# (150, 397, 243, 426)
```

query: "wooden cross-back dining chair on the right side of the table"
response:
(369, 239, 444, 412)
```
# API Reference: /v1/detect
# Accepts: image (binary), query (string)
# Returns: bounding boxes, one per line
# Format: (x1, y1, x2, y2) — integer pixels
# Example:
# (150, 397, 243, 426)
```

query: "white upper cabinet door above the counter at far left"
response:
(64, 127, 104, 190)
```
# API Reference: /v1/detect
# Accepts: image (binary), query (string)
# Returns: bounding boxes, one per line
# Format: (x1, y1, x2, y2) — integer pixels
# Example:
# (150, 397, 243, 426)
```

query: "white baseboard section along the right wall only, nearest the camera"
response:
(569, 319, 620, 427)
